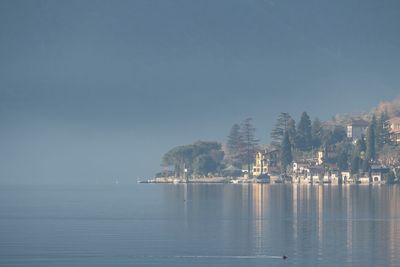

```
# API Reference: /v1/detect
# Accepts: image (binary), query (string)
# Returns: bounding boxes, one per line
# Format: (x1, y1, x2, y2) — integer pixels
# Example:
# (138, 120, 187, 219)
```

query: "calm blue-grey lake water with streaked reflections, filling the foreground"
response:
(0, 184, 400, 267)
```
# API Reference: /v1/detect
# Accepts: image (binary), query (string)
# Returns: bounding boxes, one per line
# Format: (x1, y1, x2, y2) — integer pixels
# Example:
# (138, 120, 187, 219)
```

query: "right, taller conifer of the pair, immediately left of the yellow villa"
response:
(240, 118, 258, 175)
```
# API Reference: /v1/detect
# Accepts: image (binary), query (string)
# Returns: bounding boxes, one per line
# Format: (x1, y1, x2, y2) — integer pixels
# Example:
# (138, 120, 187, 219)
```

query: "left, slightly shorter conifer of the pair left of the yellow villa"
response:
(226, 123, 243, 168)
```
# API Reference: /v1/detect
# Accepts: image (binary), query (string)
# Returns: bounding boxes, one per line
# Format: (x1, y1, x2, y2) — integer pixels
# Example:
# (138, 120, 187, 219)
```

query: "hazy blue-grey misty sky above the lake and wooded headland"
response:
(0, 0, 400, 184)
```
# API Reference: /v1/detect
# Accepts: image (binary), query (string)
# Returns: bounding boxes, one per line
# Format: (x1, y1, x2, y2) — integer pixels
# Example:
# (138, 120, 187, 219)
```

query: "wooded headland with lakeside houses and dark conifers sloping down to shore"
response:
(141, 98, 400, 184)
